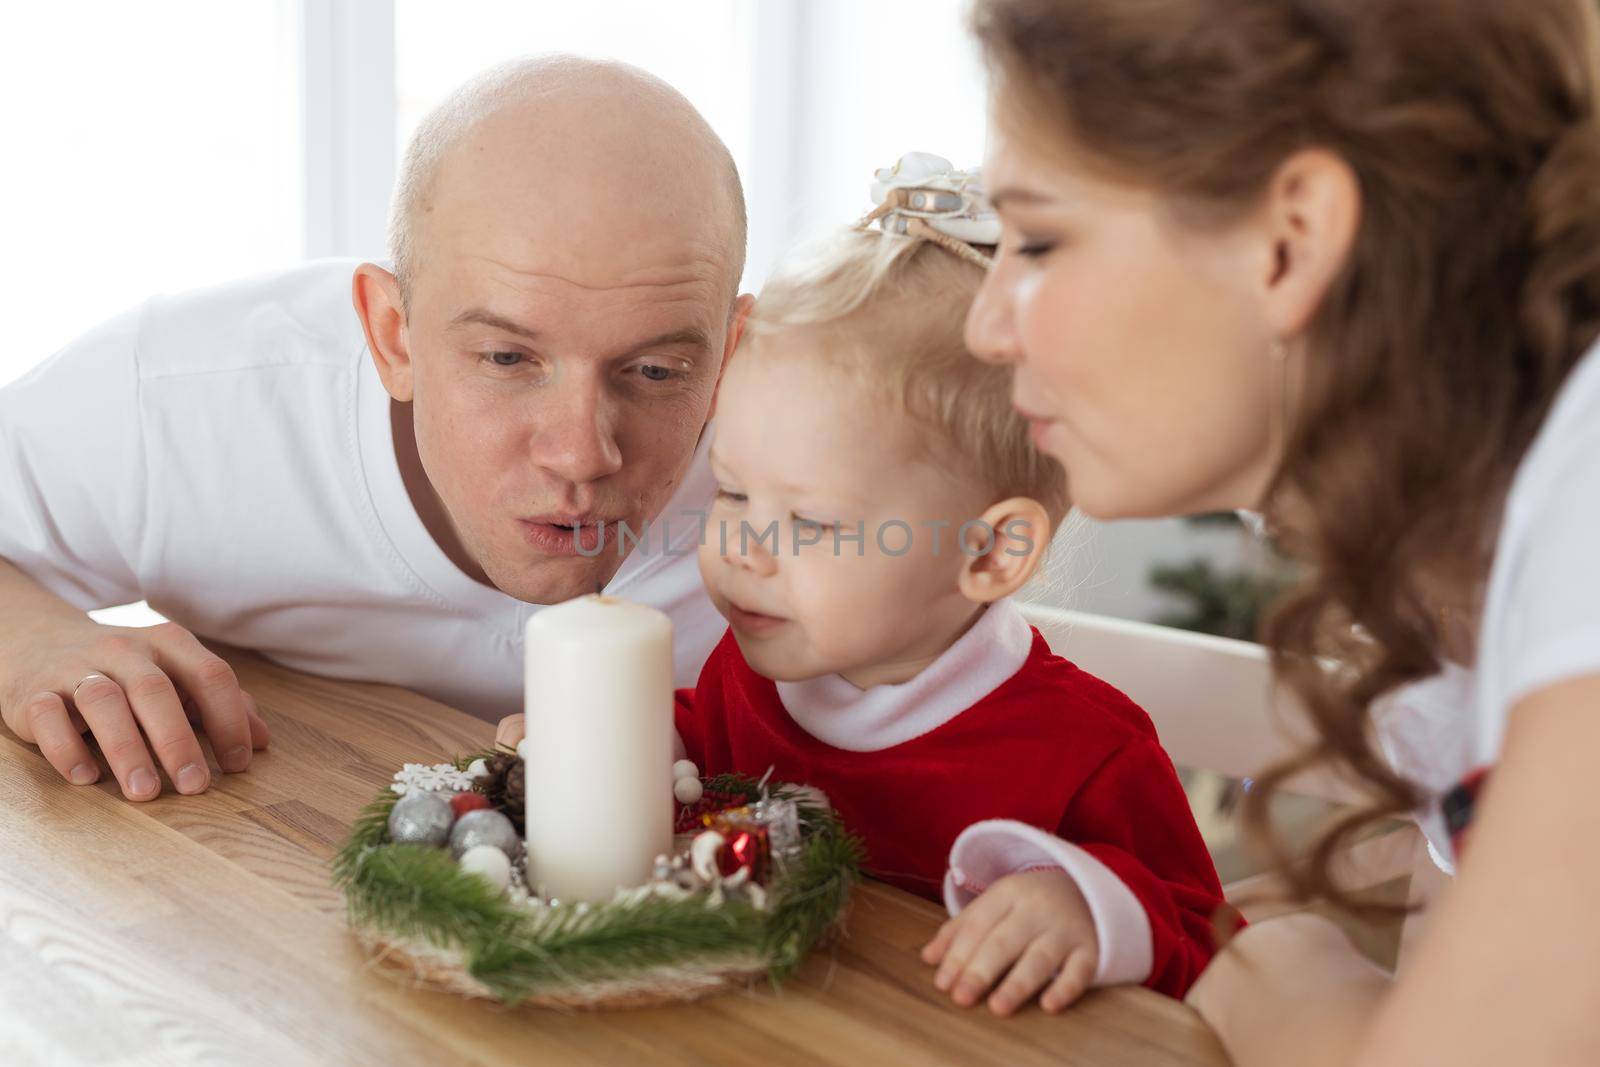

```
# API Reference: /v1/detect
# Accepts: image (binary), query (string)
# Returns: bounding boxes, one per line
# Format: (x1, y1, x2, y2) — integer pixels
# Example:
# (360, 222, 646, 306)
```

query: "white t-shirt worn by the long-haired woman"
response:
(1379, 337, 1600, 869)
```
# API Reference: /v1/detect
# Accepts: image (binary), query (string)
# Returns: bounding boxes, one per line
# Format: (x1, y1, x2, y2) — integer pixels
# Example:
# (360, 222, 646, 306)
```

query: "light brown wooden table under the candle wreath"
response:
(0, 649, 1226, 1067)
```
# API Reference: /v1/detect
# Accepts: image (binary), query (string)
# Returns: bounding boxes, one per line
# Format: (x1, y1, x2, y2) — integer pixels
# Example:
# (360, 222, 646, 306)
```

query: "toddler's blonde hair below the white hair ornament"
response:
(739, 227, 1070, 530)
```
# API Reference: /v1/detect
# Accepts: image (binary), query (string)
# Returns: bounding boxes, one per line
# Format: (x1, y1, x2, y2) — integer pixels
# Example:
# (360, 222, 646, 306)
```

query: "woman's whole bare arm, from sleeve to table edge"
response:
(1189, 675, 1600, 1067)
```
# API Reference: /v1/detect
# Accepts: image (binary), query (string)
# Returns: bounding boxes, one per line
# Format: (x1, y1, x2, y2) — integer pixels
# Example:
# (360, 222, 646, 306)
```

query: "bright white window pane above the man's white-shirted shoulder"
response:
(0, 0, 301, 386)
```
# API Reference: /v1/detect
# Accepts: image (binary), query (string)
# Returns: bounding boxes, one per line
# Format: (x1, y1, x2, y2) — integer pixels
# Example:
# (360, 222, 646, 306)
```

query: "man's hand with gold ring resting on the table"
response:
(0, 617, 269, 800)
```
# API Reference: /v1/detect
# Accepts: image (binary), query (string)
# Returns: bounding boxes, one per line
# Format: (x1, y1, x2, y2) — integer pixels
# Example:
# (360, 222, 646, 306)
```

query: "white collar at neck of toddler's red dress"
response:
(774, 598, 1034, 752)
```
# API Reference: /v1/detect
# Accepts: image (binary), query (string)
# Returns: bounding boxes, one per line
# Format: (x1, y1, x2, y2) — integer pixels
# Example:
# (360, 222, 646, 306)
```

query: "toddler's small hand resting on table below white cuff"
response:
(922, 869, 1099, 1016)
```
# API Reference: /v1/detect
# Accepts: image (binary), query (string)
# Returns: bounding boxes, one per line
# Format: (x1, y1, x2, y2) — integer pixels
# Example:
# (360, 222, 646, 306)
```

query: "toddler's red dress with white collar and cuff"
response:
(677, 601, 1222, 997)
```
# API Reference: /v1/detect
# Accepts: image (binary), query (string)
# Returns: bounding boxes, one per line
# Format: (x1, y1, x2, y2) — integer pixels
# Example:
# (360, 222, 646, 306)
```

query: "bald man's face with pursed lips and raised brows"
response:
(405, 189, 731, 603)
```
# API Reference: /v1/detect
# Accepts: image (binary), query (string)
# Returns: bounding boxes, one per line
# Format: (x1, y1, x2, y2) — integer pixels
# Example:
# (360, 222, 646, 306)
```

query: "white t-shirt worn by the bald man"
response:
(0, 261, 726, 720)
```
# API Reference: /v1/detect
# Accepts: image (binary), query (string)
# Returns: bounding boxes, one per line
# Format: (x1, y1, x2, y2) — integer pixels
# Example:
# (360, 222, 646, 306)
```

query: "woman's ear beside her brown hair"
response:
(1264, 149, 1362, 338)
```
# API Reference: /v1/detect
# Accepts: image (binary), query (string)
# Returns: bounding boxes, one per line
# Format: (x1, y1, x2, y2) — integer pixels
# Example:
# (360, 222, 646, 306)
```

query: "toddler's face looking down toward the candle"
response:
(699, 347, 992, 688)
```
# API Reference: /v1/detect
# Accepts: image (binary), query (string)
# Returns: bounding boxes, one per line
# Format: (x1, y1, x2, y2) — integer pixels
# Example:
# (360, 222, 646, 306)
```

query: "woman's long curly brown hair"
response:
(973, 0, 1600, 913)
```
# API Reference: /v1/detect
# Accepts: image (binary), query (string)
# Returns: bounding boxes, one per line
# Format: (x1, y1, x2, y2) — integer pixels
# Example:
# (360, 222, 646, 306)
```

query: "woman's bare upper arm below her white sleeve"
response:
(1360, 675, 1600, 1067)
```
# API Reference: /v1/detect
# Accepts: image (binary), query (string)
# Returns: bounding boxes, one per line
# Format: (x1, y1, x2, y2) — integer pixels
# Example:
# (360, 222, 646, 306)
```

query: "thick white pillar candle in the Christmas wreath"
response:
(523, 595, 672, 901)
